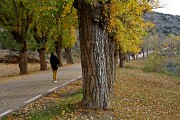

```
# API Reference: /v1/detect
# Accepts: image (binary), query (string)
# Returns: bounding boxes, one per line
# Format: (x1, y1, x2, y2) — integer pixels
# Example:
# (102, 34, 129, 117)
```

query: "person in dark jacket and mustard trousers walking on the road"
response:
(50, 52, 60, 82)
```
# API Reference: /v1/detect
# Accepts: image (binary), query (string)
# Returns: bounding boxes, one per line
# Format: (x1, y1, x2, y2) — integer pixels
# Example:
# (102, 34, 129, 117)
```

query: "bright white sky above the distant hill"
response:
(154, 0, 180, 16)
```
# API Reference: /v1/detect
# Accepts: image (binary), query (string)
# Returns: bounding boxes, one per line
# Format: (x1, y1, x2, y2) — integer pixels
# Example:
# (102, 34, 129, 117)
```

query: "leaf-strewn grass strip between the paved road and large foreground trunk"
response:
(2, 81, 82, 120)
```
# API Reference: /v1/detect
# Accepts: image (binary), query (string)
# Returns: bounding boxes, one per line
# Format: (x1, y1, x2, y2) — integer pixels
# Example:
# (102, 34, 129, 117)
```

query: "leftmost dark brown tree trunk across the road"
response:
(19, 41, 28, 75)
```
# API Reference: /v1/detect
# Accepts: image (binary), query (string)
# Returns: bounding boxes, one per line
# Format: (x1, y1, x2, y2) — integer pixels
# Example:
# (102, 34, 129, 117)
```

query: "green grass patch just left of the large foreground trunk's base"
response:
(28, 90, 82, 120)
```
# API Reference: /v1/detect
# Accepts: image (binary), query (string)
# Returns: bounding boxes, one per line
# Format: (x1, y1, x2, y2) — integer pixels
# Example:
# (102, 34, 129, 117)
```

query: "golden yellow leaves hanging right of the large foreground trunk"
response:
(108, 0, 152, 52)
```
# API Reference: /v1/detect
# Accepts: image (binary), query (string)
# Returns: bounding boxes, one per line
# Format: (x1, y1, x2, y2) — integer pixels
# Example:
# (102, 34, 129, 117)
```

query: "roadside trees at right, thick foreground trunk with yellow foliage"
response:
(74, 0, 157, 109)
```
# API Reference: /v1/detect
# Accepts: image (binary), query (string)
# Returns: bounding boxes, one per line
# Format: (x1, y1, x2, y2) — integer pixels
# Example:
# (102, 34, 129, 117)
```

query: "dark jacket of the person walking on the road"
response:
(50, 53, 60, 70)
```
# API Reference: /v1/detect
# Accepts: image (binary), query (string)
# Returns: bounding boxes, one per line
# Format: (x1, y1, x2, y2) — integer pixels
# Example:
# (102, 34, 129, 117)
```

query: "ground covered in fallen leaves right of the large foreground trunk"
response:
(112, 61, 180, 120)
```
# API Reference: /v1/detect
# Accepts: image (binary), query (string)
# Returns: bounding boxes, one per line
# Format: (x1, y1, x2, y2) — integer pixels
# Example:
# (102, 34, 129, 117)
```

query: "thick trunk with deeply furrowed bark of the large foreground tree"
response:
(75, 0, 111, 110)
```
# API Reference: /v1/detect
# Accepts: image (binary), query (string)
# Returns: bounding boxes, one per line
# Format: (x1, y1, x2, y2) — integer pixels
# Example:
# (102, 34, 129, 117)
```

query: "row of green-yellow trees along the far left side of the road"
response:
(0, 0, 77, 74)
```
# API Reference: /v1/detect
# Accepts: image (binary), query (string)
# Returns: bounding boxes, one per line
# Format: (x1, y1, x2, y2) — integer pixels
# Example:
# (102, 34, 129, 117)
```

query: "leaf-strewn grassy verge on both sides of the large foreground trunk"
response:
(3, 61, 180, 120)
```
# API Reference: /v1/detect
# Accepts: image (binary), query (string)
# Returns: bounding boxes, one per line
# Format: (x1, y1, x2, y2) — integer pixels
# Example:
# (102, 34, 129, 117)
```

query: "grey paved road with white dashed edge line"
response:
(0, 64, 82, 118)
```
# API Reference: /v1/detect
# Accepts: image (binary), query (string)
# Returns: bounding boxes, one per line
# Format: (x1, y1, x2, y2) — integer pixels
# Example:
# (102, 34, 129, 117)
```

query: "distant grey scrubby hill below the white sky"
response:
(144, 12, 180, 35)
